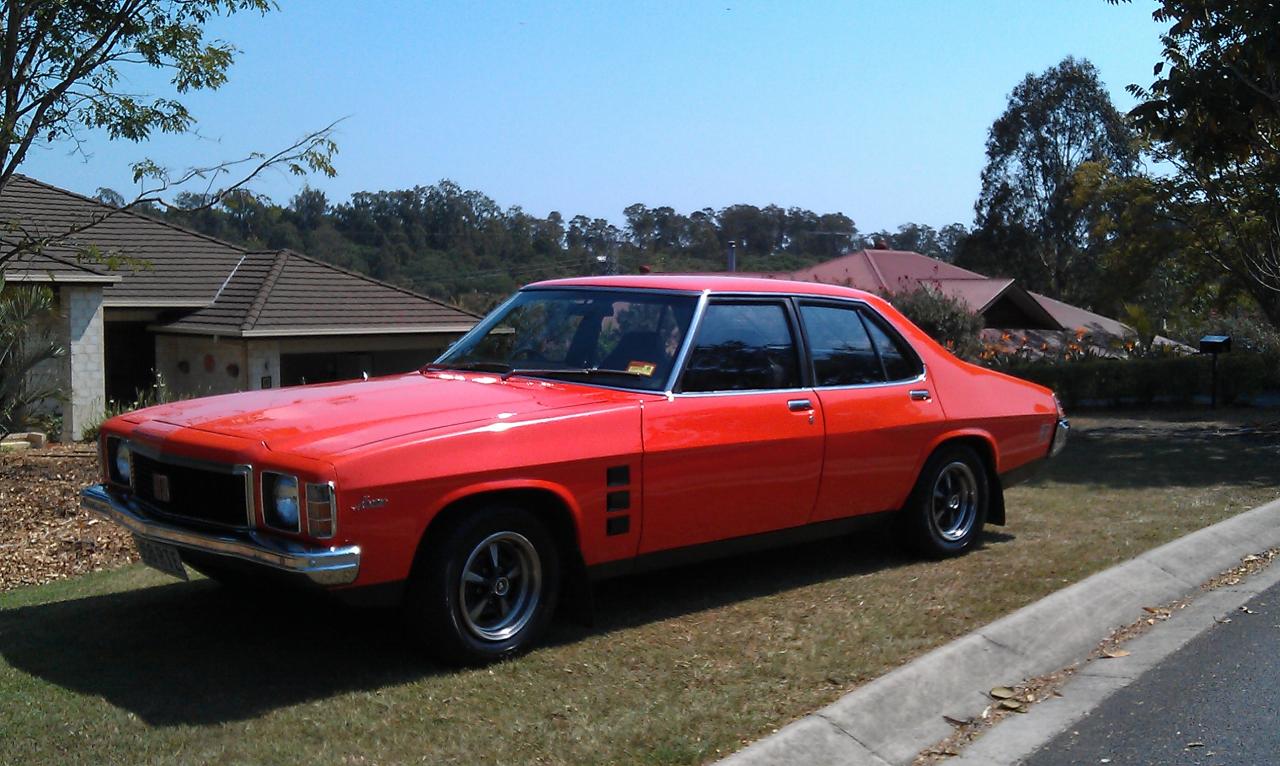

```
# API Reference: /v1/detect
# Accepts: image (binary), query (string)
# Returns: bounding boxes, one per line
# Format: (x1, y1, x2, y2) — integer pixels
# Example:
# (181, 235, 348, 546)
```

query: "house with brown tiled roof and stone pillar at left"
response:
(0, 175, 479, 439)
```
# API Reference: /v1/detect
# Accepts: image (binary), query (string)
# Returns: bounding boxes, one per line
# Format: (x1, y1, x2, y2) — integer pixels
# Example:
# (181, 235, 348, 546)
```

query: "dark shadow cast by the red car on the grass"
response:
(0, 528, 1011, 726)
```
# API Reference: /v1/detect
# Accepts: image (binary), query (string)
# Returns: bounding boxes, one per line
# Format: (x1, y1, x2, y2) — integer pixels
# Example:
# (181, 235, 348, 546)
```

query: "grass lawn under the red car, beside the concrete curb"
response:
(0, 412, 1280, 765)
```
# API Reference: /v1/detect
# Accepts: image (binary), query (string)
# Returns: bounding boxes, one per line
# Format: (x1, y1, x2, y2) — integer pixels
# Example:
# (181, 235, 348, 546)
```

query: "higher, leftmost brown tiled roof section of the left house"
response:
(0, 175, 244, 307)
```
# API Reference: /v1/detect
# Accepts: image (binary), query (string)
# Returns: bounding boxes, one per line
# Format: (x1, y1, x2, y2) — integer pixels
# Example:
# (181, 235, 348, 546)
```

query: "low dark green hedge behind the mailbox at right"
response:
(1002, 352, 1280, 409)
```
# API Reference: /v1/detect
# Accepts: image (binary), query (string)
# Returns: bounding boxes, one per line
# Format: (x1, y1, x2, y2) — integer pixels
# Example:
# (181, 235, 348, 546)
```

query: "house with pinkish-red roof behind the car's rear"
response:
(721, 247, 1137, 347)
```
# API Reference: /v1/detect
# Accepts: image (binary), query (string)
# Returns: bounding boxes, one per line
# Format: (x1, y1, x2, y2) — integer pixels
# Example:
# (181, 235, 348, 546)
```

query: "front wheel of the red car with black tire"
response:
(404, 506, 559, 665)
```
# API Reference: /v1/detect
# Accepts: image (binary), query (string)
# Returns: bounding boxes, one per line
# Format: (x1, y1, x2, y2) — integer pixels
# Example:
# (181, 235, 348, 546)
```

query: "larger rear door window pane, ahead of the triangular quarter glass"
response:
(800, 305, 884, 386)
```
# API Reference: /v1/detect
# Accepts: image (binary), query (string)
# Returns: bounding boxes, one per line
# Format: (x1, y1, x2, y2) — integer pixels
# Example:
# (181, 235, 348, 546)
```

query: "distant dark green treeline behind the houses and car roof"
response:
(99, 181, 968, 309)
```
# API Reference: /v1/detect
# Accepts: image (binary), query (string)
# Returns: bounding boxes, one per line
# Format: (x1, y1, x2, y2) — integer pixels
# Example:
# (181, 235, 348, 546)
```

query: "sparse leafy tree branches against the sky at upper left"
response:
(0, 0, 338, 268)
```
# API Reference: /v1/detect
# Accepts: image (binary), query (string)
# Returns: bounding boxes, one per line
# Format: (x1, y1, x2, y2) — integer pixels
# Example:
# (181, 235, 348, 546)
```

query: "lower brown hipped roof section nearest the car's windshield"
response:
(152, 250, 477, 337)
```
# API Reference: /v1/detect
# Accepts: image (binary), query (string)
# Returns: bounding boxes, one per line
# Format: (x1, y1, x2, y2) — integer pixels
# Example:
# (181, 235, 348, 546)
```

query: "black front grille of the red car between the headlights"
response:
(133, 452, 250, 526)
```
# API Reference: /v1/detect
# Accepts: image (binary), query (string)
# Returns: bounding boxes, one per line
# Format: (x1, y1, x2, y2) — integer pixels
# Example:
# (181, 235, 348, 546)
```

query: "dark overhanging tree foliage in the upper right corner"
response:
(1112, 0, 1280, 327)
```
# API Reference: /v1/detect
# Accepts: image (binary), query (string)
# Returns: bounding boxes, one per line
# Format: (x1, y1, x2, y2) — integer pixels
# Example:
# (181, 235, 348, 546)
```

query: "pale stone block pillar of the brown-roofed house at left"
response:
(60, 284, 106, 442)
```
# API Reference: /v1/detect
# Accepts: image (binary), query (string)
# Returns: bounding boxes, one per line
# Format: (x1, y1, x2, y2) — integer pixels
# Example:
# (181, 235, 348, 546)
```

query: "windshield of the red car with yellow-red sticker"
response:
(429, 288, 698, 391)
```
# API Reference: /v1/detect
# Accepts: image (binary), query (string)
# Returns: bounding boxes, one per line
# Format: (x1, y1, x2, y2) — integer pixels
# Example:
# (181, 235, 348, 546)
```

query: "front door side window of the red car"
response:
(680, 302, 800, 392)
